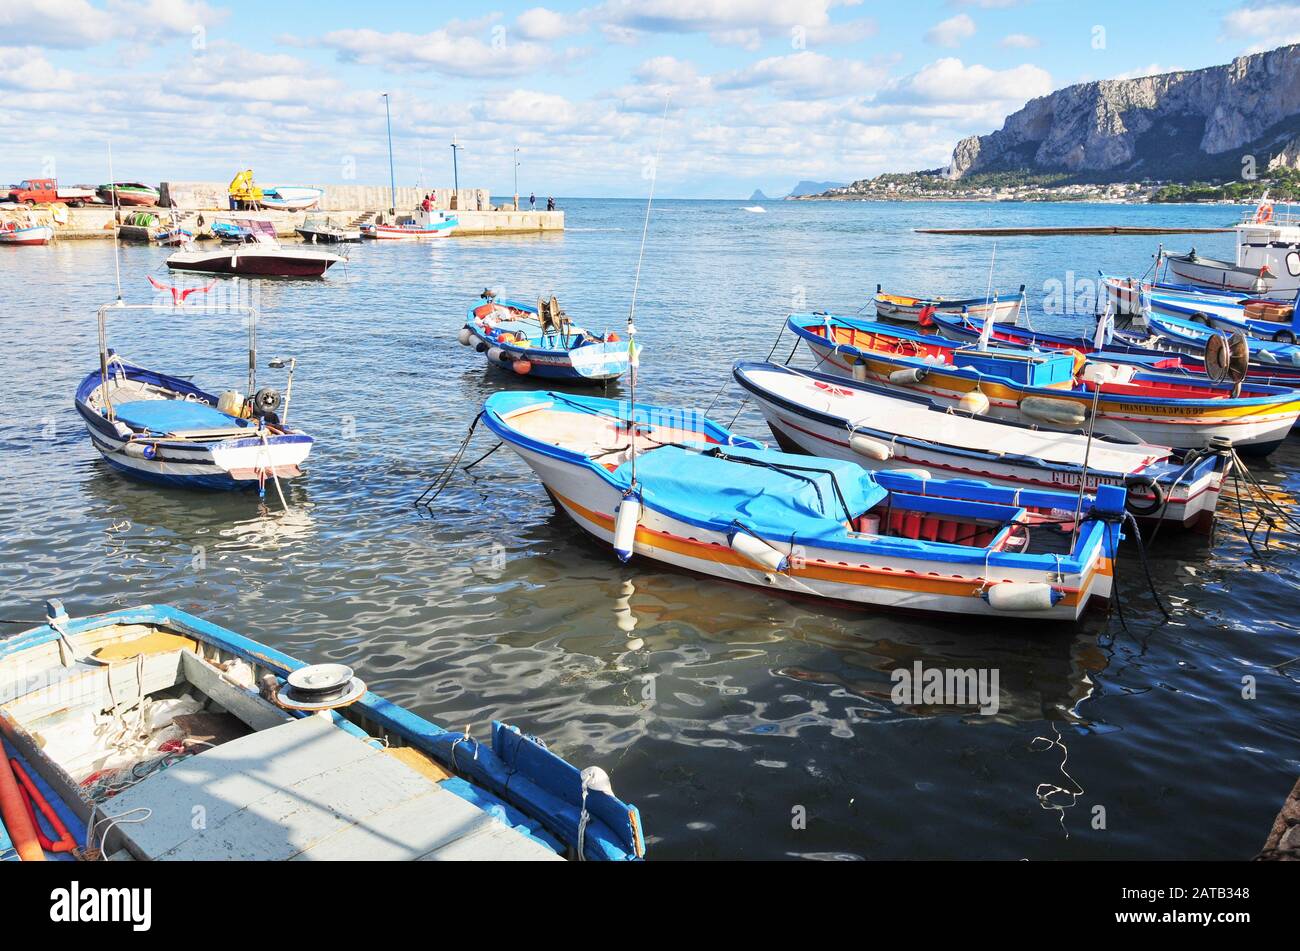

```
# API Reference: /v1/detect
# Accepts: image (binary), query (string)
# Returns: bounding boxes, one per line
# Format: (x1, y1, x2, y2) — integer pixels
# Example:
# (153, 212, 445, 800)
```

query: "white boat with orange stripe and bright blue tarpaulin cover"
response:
(482, 392, 1125, 621)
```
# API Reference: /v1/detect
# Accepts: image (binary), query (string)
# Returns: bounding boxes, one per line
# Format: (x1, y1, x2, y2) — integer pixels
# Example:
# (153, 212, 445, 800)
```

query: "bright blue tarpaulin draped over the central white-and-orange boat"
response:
(612, 446, 888, 539)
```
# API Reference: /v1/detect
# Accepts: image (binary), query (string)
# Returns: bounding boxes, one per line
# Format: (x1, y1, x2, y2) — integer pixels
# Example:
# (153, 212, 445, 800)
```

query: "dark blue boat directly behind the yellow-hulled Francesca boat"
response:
(933, 313, 1300, 387)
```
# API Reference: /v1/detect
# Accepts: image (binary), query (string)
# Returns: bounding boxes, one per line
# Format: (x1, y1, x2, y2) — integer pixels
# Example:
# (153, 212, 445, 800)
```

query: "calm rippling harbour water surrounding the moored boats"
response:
(0, 200, 1300, 859)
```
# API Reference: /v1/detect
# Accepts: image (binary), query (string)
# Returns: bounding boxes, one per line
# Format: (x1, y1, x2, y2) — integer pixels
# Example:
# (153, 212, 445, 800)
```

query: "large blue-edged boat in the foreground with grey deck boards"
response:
(0, 602, 645, 861)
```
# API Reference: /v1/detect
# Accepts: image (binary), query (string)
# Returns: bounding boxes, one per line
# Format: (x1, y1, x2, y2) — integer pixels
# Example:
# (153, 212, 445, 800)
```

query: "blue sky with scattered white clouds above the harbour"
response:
(0, 0, 1300, 197)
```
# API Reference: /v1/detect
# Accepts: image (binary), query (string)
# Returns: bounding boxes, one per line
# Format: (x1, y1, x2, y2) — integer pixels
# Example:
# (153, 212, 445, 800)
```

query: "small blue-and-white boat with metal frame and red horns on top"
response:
(75, 288, 312, 491)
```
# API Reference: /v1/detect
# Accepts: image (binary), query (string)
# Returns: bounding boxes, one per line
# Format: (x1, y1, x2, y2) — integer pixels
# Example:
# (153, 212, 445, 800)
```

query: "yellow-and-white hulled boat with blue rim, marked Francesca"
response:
(787, 314, 1300, 455)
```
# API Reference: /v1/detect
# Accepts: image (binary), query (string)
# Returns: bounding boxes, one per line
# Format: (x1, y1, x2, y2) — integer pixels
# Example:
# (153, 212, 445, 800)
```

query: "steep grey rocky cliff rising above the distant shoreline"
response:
(948, 45, 1300, 181)
